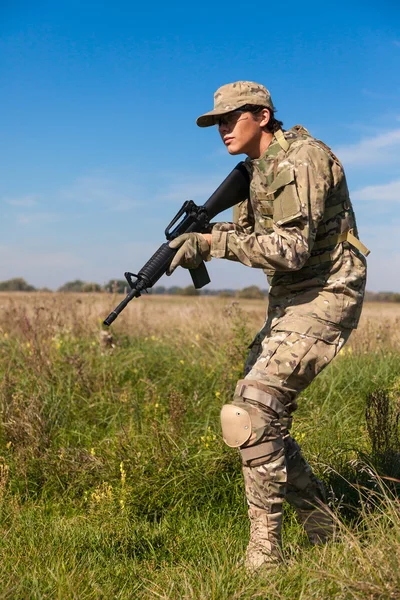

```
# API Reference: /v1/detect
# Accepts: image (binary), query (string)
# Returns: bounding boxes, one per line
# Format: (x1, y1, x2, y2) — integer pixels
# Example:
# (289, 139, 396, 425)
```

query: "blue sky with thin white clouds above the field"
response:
(0, 0, 400, 292)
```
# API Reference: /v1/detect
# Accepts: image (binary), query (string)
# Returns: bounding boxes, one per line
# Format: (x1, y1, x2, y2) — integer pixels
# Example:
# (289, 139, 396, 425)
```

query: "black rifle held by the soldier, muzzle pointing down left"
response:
(104, 162, 250, 325)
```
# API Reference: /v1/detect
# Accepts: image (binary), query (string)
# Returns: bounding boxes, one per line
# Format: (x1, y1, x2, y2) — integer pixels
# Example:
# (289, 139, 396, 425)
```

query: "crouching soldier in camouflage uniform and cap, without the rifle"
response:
(166, 81, 368, 569)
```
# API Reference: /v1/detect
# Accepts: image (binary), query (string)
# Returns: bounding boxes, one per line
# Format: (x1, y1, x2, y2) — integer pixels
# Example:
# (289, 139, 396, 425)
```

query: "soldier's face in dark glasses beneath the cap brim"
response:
(217, 109, 272, 158)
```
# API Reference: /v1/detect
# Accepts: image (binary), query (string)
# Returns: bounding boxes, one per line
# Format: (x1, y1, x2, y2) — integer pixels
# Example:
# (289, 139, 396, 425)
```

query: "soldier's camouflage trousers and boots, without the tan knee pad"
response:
(228, 329, 350, 569)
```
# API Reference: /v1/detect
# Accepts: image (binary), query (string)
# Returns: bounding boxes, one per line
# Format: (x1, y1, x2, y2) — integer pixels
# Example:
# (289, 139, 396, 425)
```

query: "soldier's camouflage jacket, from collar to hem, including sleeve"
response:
(211, 125, 366, 341)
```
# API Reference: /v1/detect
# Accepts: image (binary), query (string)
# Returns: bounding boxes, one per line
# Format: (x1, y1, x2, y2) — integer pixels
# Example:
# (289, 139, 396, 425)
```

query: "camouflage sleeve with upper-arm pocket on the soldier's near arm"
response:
(211, 143, 332, 271)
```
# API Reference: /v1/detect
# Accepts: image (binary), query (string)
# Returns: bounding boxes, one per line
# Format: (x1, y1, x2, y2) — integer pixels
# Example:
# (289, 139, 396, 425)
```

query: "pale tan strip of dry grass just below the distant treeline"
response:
(0, 292, 400, 353)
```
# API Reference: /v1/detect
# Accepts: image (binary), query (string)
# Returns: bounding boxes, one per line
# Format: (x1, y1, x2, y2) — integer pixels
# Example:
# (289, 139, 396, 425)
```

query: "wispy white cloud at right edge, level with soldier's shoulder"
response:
(335, 129, 400, 167)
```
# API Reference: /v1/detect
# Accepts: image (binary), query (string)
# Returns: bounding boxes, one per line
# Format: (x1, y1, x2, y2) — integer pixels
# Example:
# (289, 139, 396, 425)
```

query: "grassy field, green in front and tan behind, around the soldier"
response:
(0, 293, 400, 600)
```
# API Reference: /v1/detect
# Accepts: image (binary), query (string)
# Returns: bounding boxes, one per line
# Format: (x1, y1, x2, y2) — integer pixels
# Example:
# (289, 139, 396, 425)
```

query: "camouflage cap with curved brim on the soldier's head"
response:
(196, 81, 275, 127)
